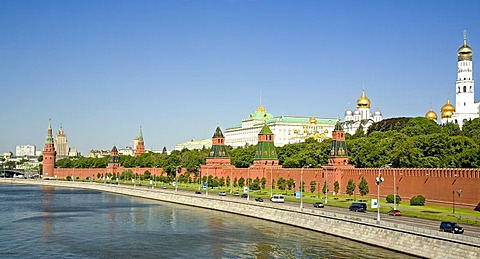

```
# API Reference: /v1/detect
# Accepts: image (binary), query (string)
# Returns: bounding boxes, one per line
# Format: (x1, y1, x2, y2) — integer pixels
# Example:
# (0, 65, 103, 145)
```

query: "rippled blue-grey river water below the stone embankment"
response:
(0, 184, 416, 258)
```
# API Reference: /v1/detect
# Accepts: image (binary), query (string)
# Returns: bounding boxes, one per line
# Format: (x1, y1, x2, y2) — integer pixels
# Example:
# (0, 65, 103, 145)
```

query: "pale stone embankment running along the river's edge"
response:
(0, 179, 480, 258)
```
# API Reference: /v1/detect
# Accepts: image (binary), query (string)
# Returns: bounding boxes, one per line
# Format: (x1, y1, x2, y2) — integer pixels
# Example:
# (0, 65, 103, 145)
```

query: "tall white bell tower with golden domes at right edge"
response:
(425, 31, 480, 128)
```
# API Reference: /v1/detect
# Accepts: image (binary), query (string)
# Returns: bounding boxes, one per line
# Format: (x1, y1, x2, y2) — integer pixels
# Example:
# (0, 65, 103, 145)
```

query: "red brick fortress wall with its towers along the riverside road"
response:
(43, 121, 480, 208)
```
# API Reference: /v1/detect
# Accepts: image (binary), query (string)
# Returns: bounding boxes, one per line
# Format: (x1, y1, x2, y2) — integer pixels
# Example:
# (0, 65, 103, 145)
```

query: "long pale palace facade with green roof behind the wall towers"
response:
(225, 104, 337, 147)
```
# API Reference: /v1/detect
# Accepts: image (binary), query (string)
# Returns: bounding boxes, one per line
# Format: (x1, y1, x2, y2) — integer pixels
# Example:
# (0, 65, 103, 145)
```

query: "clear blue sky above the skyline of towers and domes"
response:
(0, 0, 480, 155)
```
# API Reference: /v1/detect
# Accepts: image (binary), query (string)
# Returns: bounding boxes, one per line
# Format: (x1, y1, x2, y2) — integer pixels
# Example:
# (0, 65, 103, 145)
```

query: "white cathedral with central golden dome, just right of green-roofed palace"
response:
(342, 90, 382, 135)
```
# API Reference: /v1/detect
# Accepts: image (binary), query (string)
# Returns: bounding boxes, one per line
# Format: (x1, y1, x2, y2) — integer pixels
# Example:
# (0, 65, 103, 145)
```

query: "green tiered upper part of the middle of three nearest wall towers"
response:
(253, 124, 278, 165)
